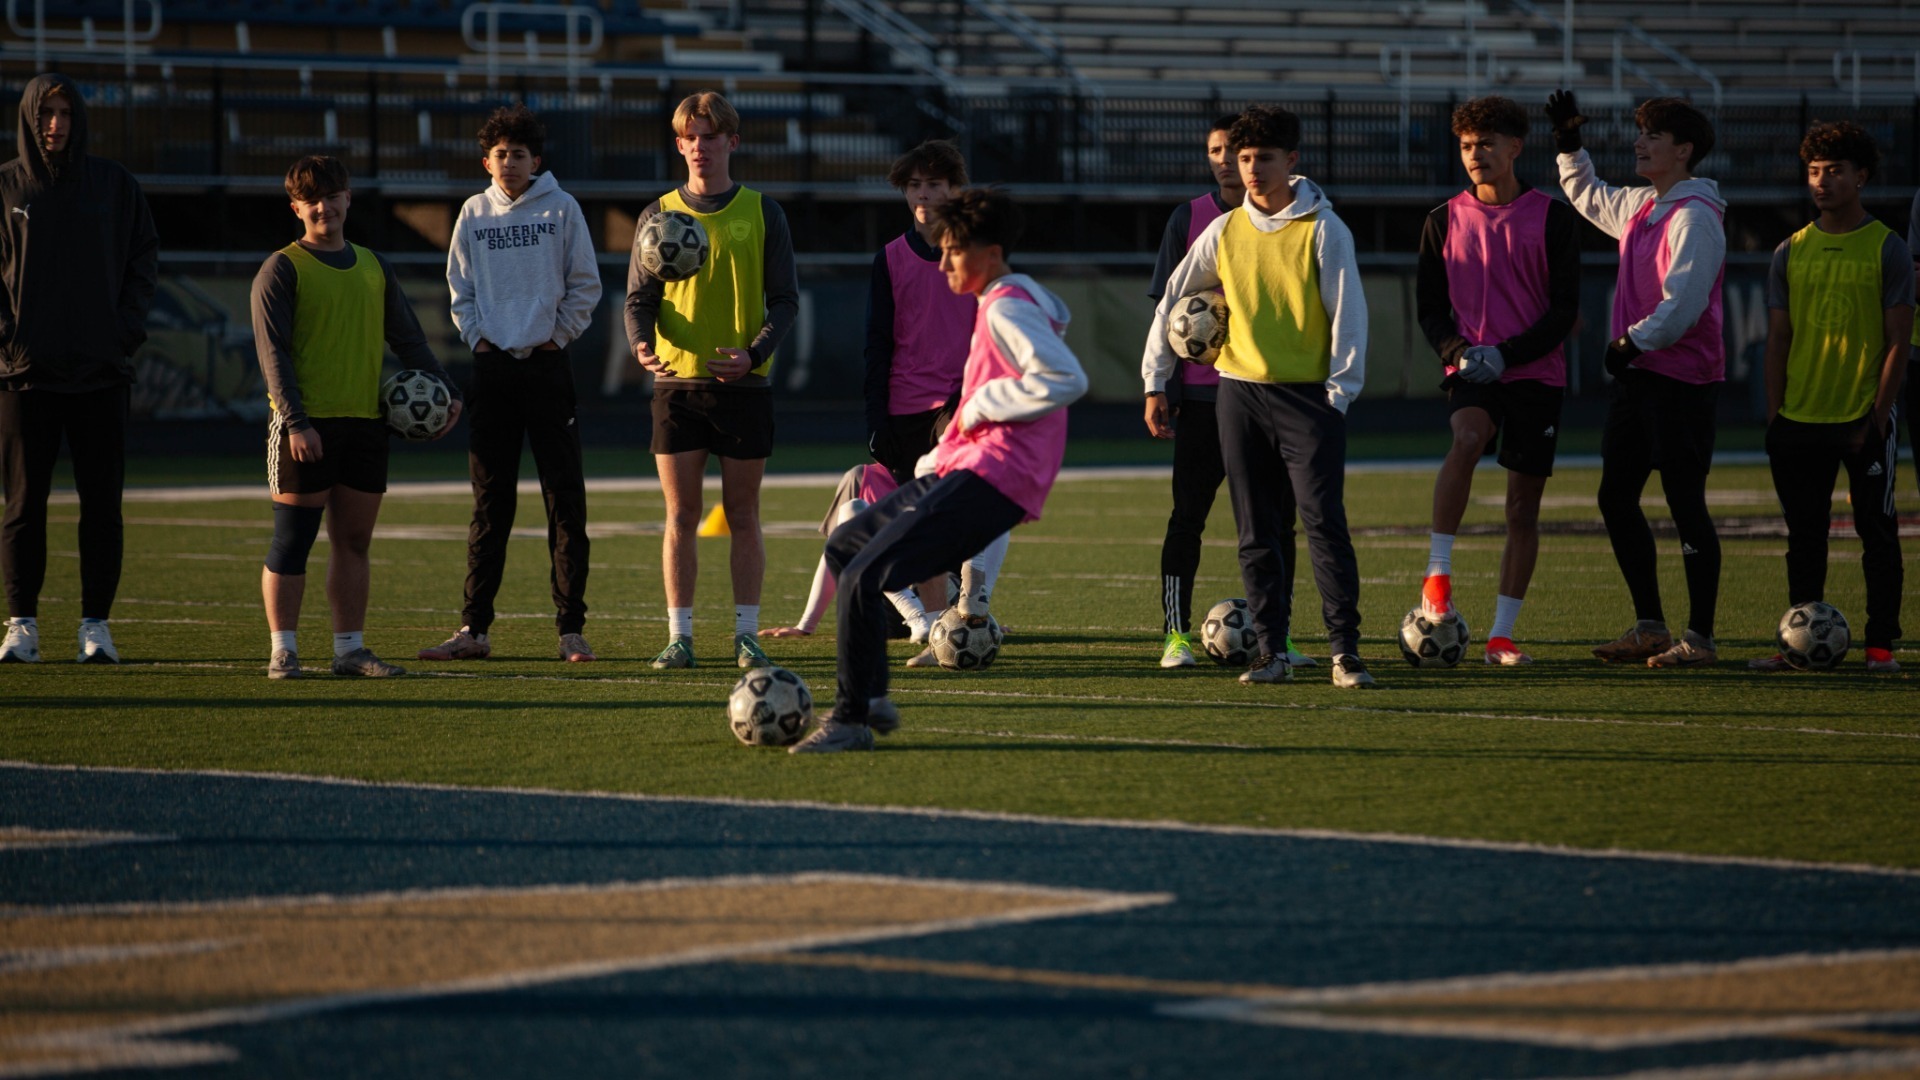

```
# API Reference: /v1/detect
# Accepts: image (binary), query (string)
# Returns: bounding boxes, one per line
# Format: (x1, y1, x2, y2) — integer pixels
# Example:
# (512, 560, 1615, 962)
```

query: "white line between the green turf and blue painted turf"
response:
(0, 759, 1920, 878)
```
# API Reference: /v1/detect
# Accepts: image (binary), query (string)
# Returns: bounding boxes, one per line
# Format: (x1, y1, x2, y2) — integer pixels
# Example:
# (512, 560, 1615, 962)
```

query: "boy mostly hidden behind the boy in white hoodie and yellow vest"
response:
(1142, 115, 1317, 667)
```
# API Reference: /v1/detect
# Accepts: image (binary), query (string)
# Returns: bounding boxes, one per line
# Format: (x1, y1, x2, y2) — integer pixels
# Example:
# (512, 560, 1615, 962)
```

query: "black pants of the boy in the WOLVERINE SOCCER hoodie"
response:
(461, 350, 589, 634)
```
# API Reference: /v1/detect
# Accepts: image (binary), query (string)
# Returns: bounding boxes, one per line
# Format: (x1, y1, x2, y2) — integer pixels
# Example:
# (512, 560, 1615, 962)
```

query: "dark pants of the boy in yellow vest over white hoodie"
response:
(1217, 379, 1359, 655)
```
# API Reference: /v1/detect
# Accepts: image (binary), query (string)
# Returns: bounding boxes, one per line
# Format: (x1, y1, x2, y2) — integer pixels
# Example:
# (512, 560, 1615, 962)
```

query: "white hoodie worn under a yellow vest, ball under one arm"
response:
(1140, 177, 1367, 413)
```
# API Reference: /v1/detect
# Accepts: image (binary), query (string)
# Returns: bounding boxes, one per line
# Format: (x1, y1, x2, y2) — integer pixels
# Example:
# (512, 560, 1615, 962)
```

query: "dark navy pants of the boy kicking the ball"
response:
(828, 469, 1027, 723)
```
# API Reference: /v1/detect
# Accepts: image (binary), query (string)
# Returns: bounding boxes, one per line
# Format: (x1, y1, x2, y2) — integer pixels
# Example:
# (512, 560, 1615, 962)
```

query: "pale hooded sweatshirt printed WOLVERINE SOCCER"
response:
(447, 173, 601, 359)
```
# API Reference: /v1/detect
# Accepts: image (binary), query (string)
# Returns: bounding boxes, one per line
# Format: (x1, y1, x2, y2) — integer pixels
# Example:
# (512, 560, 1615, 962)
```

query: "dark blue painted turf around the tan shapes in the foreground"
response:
(0, 767, 1920, 1078)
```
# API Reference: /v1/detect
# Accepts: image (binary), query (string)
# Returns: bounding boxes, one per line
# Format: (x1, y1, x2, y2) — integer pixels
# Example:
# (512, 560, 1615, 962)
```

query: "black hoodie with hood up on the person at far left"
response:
(0, 75, 159, 394)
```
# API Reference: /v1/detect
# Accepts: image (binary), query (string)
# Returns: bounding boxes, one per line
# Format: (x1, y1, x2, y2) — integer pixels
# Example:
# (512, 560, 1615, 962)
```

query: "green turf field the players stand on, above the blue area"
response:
(0, 467, 1920, 867)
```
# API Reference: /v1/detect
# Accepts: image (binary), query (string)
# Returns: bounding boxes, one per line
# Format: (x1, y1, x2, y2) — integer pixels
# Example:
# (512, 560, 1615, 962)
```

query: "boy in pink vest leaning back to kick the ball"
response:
(793, 190, 1087, 753)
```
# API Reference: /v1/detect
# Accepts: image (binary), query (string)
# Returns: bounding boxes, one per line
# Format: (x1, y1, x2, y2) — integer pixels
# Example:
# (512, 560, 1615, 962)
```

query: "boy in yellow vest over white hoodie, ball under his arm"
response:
(1140, 106, 1373, 688)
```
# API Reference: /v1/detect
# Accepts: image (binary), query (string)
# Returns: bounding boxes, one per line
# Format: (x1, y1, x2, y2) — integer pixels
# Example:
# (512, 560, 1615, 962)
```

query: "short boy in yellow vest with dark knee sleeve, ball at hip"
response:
(253, 158, 461, 678)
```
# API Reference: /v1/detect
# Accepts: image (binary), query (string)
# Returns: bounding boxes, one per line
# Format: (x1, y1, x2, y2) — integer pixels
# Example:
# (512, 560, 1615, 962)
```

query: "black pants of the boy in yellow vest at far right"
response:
(1766, 417, 1905, 650)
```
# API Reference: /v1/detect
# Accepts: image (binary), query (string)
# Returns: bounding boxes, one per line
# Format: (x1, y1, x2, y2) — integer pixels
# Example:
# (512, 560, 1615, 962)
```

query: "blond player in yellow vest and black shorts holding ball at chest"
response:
(626, 90, 801, 669)
